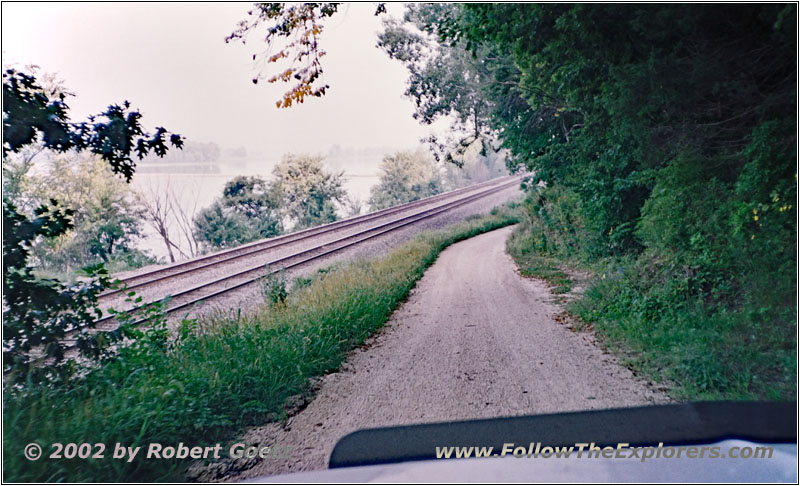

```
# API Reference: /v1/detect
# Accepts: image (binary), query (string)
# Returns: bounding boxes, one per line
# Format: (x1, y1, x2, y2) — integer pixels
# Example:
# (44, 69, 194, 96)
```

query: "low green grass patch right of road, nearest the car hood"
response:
(569, 263, 797, 401)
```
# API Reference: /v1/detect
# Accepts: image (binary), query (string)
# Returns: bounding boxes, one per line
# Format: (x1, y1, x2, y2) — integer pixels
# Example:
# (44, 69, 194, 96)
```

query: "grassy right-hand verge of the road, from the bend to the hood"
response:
(507, 216, 797, 401)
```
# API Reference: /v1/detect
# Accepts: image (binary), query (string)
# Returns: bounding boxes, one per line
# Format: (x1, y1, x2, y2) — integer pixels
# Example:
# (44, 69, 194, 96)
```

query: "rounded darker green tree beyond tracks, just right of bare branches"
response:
(194, 176, 283, 248)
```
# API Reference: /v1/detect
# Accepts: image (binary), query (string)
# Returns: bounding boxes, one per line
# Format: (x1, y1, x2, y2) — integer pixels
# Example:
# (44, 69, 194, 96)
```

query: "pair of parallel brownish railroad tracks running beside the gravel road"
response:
(81, 176, 520, 334)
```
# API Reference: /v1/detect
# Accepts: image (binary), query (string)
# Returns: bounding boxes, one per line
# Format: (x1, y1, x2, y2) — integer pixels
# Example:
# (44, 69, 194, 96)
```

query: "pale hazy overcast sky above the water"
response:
(2, 3, 429, 157)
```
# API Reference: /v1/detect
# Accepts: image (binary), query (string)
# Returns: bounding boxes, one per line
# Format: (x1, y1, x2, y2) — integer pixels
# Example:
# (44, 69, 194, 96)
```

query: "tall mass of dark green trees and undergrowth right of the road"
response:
(376, 4, 797, 399)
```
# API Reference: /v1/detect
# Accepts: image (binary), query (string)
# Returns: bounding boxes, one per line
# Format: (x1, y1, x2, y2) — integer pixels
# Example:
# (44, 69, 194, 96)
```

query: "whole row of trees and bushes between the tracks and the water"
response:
(3, 68, 491, 272)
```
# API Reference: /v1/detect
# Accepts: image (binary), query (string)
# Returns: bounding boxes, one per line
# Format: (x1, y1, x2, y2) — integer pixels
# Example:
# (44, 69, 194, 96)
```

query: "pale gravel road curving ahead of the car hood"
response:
(225, 228, 668, 481)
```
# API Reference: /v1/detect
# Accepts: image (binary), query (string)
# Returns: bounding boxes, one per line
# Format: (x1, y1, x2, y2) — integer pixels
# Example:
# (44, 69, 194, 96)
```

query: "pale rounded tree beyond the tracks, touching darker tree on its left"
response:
(272, 154, 346, 230)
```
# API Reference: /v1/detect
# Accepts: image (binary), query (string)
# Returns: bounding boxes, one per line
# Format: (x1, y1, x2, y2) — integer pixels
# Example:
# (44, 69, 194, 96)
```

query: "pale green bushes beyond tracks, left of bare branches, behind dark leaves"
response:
(3, 150, 155, 280)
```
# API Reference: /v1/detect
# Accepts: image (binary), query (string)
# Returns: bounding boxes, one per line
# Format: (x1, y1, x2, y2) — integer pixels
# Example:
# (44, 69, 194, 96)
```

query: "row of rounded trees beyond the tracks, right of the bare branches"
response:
(194, 150, 504, 251)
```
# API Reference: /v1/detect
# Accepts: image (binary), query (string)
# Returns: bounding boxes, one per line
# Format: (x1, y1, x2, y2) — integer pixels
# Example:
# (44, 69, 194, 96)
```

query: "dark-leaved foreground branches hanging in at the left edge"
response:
(3, 70, 183, 383)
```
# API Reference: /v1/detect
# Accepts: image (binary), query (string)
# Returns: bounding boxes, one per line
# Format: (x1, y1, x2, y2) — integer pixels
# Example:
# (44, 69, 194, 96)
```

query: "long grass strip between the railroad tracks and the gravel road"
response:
(3, 205, 519, 482)
